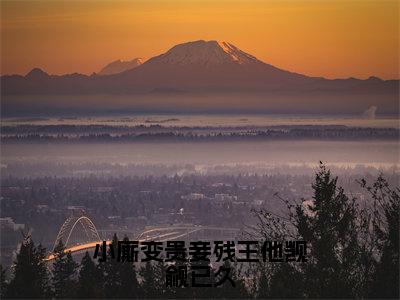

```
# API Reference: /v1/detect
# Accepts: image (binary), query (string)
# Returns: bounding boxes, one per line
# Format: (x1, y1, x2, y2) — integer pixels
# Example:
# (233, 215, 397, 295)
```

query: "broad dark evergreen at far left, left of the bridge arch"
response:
(7, 237, 49, 298)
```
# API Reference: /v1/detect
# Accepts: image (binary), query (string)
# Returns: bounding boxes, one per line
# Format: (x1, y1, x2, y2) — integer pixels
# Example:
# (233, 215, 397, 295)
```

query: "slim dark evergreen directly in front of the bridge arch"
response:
(52, 241, 78, 298)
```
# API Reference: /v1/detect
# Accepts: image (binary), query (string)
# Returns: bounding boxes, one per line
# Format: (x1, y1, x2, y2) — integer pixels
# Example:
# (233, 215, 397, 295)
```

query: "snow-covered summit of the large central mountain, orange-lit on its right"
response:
(149, 40, 262, 67)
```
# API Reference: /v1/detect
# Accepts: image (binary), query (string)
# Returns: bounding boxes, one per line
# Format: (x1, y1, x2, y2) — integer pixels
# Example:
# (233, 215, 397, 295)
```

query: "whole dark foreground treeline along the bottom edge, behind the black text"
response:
(1, 165, 400, 298)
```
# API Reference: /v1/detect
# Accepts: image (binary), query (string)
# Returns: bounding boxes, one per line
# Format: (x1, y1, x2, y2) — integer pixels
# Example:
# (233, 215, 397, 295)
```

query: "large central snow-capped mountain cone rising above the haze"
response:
(110, 40, 315, 91)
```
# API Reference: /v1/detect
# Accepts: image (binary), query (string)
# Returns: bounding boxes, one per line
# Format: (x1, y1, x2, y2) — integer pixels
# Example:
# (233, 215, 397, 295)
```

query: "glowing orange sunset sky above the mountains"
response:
(1, 0, 400, 79)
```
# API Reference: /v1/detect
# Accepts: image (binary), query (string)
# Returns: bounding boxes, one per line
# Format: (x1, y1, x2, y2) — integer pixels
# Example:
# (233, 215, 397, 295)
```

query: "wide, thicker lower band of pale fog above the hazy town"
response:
(1, 141, 399, 175)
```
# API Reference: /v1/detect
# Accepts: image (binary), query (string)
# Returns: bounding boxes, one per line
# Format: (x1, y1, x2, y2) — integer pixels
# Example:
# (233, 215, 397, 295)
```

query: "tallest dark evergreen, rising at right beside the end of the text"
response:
(296, 163, 359, 298)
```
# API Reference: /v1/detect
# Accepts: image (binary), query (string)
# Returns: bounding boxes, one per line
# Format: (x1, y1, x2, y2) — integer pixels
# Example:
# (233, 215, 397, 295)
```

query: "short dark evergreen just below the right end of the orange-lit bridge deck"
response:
(77, 251, 103, 298)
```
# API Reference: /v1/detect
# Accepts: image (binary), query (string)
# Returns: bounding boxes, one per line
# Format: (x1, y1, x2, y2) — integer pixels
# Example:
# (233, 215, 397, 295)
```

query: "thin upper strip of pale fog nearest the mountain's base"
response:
(1, 112, 400, 128)
